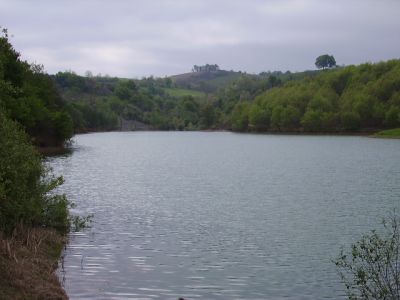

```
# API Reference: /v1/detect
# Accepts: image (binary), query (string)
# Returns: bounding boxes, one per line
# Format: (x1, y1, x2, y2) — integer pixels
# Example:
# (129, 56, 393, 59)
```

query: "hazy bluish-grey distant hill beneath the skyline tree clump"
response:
(169, 70, 243, 93)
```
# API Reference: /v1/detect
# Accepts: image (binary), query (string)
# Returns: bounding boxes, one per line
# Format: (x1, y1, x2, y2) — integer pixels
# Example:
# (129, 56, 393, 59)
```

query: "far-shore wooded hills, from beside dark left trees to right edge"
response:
(52, 60, 400, 132)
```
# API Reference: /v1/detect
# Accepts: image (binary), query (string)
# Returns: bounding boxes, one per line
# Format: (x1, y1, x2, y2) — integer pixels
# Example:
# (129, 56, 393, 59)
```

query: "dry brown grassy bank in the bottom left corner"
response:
(0, 227, 68, 300)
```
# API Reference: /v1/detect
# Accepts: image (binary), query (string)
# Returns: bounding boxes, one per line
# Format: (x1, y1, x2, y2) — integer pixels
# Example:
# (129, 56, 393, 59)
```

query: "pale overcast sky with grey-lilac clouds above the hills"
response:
(0, 0, 400, 77)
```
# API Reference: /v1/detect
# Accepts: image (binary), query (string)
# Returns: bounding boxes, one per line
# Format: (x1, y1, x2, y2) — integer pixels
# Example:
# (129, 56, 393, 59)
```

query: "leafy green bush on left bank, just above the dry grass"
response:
(0, 113, 69, 233)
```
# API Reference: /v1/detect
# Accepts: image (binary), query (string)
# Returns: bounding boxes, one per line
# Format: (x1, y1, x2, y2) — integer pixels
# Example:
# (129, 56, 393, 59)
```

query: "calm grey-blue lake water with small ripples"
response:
(49, 132, 400, 299)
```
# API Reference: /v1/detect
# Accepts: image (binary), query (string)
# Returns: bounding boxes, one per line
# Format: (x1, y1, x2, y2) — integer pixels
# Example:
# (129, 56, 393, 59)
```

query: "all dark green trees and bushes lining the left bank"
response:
(0, 30, 73, 237)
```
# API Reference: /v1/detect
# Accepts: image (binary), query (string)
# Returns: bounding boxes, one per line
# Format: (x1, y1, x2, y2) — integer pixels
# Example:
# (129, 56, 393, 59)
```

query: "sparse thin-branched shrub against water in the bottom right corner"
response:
(335, 214, 400, 299)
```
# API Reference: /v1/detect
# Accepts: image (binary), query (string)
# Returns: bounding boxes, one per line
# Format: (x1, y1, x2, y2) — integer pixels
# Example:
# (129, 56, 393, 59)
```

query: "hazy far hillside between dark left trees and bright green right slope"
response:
(53, 70, 314, 132)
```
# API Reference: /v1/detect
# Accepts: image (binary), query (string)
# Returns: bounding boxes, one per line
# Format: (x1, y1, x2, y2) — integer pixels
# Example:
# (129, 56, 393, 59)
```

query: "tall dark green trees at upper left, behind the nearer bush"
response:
(0, 30, 73, 146)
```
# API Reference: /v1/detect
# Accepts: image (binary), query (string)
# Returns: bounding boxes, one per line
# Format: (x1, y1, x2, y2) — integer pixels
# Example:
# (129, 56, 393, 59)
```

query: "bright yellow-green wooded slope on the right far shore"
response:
(231, 60, 400, 132)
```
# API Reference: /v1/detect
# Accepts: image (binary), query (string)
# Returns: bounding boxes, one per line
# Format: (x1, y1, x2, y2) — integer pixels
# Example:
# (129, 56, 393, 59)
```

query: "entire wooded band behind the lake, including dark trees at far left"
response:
(4, 22, 400, 136)
